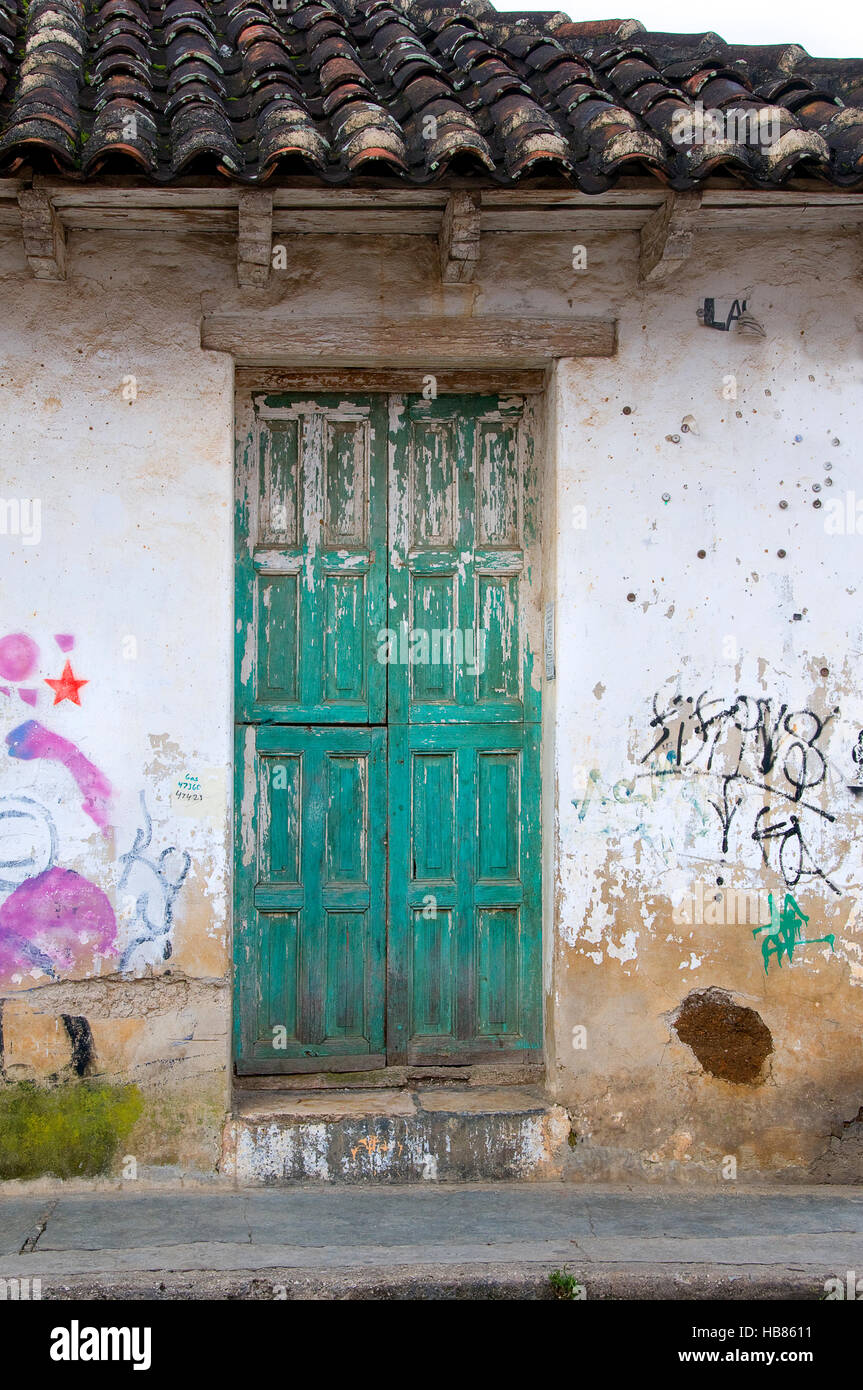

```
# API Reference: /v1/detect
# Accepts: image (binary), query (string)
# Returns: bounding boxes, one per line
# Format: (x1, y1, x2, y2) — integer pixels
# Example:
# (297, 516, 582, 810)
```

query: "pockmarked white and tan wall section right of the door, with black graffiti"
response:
(553, 227, 863, 1177)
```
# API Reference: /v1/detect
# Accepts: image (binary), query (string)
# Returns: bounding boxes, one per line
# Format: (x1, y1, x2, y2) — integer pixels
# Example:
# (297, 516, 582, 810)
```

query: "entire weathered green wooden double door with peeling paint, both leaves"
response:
(233, 395, 542, 1073)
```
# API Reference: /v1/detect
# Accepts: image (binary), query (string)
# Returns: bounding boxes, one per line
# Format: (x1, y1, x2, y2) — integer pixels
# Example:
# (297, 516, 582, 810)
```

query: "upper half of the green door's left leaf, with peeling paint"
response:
(236, 396, 386, 724)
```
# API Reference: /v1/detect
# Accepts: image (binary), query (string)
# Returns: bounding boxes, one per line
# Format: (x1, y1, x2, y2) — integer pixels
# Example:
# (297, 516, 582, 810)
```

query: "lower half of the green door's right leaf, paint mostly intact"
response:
(388, 724, 542, 1062)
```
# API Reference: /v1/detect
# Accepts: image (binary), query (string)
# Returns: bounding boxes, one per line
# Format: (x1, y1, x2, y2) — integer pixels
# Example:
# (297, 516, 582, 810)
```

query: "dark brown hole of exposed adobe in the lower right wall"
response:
(674, 987, 773, 1086)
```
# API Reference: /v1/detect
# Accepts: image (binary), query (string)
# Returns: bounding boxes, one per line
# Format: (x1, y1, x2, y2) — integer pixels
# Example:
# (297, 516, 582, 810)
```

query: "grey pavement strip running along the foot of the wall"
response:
(0, 1183, 863, 1300)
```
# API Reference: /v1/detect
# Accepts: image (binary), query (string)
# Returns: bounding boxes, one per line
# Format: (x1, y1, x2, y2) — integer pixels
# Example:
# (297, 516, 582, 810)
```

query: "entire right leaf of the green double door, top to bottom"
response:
(388, 396, 542, 1063)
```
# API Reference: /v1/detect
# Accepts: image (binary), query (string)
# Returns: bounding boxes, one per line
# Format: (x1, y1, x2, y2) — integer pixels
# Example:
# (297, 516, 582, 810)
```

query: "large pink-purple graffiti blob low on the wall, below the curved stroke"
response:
(0, 869, 117, 976)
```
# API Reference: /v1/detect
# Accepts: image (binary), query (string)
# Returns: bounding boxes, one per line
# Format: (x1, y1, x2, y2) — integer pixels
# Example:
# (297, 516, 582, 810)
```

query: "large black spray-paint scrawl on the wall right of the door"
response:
(641, 692, 841, 894)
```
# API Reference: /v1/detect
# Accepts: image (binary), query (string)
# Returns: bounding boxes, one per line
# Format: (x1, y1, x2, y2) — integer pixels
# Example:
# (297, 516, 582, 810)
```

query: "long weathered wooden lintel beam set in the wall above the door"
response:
(200, 314, 617, 374)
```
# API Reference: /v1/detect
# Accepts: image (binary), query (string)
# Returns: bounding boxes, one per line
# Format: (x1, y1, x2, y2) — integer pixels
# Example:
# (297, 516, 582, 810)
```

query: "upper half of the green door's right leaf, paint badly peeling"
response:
(386, 396, 539, 724)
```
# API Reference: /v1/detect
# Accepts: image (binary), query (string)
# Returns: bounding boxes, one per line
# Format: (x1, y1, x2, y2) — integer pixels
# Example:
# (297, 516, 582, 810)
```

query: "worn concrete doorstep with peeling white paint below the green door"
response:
(221, 1086, 570, 1183)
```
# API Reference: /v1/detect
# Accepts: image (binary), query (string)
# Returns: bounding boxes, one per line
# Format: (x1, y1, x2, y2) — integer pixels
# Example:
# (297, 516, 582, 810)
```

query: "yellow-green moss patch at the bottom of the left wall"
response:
(0, 1081, 143, 1179)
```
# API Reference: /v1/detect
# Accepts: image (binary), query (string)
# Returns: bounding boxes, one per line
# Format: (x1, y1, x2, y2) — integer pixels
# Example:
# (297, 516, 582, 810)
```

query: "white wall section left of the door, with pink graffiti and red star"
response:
(0, 225, 232, 1168)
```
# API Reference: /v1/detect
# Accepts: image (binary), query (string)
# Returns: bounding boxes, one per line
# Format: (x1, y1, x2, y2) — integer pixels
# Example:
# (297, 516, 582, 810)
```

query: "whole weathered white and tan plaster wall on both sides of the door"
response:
(0, 219, 863, 1177)
